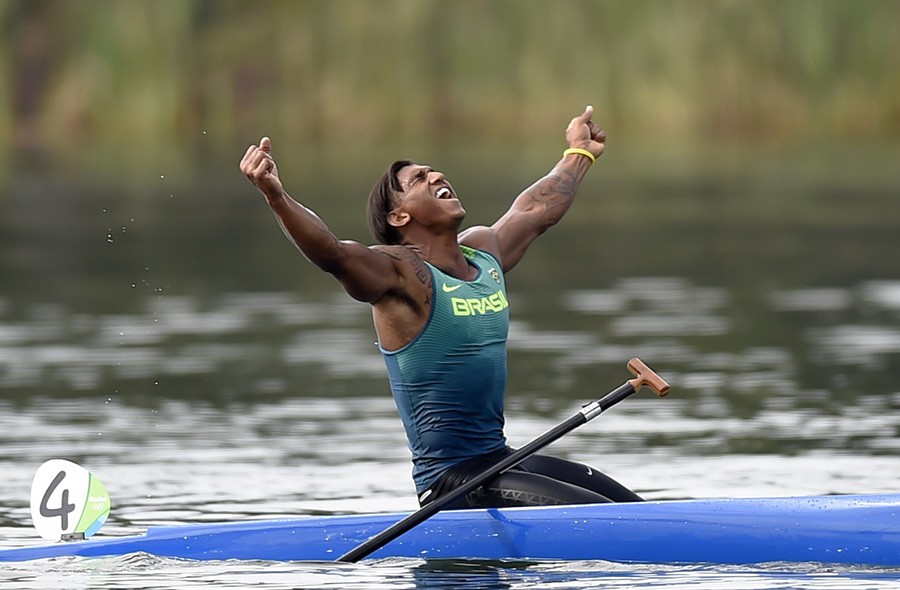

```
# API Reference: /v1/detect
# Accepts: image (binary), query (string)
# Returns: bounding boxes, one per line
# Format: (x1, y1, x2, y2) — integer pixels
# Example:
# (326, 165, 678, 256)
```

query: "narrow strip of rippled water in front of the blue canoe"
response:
(5, 555, 897, 590)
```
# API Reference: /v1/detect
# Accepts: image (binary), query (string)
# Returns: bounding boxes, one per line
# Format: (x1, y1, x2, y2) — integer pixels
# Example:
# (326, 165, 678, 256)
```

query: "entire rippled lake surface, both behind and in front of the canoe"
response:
(0, 146, 900, 589)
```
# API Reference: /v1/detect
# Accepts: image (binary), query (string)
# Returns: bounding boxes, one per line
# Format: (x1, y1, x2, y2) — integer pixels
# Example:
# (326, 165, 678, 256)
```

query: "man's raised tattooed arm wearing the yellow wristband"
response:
(491, 106, 606, 271)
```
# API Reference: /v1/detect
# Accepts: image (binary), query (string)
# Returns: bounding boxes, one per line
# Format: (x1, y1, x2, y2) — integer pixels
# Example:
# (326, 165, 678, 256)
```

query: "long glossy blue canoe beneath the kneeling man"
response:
(0, 494, 900, 566)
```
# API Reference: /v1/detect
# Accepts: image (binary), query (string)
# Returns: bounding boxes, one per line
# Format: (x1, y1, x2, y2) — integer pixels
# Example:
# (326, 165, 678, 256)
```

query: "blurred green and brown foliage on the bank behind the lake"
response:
(0, 0, 900, 169)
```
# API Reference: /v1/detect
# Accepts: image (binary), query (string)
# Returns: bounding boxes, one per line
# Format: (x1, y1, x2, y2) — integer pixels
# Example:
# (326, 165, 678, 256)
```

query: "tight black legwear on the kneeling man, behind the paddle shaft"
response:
(419, 447, 642, 509)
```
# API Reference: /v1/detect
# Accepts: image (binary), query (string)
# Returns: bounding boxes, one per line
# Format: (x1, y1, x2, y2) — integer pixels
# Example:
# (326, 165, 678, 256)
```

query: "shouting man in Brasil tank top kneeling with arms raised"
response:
(241, 106, 641, 508)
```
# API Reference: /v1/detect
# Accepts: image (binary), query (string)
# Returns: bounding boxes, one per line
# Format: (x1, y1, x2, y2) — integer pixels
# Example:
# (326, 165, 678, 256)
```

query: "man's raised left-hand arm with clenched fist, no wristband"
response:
(241, 137, 399, 303)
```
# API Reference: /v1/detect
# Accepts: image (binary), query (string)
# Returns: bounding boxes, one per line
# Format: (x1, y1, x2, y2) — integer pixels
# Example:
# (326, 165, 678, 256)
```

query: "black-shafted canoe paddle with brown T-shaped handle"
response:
(337, 359, 669, 563)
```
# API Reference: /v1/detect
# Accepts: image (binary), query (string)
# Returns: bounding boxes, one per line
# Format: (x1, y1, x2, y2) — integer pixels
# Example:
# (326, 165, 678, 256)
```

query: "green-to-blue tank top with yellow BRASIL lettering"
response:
(381, 247, 509, 493)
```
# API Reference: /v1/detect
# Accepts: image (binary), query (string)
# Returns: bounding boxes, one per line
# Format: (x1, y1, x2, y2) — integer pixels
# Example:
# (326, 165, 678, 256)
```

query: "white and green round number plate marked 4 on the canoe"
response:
(31, 459, 110, 541)
